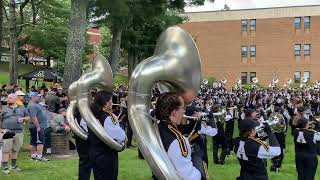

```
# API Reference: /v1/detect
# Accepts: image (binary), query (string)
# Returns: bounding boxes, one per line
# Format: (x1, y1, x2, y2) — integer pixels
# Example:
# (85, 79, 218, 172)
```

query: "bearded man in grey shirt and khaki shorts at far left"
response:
(0, 94, 29, 173)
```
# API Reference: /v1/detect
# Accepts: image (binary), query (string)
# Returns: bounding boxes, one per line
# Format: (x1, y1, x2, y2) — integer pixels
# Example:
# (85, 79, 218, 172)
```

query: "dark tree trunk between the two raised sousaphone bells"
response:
(109, 28, 122, 77)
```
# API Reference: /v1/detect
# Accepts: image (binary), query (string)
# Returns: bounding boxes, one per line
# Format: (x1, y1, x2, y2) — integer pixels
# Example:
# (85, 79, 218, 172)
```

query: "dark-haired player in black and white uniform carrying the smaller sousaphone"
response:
(88, 91, 126, 180)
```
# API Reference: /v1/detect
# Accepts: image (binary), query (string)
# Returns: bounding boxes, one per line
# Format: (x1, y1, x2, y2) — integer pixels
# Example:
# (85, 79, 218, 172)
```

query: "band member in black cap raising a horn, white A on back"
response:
(234, 118, 281, 180)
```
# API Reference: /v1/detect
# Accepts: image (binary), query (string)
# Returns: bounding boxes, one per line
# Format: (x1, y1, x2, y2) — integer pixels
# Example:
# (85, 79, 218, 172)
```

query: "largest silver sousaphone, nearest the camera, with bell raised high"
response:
(128, 26, 201, 179)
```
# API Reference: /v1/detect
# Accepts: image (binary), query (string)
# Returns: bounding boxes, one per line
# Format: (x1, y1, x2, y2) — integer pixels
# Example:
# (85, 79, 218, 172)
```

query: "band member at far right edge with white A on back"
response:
(294, 118, 320, 180)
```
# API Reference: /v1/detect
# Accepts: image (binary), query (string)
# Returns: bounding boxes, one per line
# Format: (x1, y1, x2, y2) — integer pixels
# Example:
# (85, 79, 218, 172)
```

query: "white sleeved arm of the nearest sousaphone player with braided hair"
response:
(167, 140, 201, 180)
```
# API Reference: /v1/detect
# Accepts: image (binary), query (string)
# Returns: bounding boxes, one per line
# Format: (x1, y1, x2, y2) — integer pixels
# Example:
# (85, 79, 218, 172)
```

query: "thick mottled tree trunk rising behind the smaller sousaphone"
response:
(63, 0, 88, 90)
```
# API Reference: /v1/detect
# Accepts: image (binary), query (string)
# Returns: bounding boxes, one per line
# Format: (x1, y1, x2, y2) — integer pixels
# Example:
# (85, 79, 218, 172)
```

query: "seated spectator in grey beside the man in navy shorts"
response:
(51, 108, 70, 133)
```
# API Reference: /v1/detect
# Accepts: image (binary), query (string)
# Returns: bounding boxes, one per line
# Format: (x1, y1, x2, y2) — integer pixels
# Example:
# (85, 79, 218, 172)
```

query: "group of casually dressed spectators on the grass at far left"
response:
(0, 85, 70, 174)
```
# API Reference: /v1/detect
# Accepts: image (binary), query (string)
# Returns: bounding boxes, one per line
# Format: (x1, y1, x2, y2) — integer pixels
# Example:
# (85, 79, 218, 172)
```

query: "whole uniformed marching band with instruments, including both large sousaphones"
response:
(68, 27, 320, 180)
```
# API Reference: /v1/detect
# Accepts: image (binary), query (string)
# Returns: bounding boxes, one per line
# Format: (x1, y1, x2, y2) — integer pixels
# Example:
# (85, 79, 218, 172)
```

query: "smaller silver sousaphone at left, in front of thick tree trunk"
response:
(67, 55, 123, 151)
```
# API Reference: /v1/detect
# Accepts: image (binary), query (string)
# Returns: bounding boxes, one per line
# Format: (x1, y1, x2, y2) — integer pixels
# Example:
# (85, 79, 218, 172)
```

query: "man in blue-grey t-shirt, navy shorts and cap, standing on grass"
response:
(27, 92, 48, 161)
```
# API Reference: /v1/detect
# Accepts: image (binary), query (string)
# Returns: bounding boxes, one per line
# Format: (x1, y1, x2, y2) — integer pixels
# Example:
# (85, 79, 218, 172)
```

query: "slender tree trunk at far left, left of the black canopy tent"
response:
(9, 0, 18, 84)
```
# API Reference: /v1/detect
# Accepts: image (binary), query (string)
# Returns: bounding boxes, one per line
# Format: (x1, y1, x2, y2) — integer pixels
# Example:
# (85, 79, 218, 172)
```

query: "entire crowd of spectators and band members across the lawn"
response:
(0, 81, 320, 180)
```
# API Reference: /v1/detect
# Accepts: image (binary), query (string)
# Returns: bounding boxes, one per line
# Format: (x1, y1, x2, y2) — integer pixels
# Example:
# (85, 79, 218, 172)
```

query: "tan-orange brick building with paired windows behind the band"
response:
(181, 5, 320, 87)
